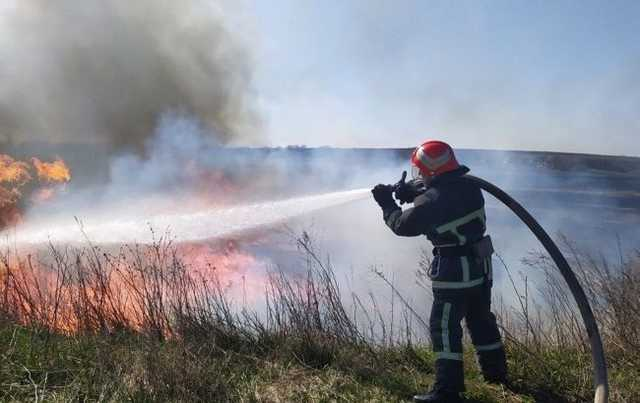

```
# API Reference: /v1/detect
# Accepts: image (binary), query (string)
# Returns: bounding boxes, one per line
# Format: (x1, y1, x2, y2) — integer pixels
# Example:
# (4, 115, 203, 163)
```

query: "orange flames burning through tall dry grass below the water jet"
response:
(0, 244, 266, 337)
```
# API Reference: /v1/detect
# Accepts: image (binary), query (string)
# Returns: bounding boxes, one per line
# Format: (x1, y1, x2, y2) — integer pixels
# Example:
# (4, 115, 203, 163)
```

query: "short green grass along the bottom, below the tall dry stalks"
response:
(0, 325, 592, 402)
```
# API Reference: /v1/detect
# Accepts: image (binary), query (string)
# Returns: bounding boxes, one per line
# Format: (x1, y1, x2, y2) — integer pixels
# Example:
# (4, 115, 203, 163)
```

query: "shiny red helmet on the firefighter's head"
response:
(411, 140, 460, 177)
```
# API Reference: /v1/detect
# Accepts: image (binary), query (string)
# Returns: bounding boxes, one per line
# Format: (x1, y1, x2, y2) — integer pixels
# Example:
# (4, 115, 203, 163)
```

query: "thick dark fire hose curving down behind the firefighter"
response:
(393, 172, 609, 403)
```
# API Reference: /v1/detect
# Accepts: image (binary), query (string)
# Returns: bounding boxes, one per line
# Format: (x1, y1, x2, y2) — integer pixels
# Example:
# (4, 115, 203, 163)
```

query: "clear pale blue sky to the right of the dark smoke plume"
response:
(248, 0, 640, 156)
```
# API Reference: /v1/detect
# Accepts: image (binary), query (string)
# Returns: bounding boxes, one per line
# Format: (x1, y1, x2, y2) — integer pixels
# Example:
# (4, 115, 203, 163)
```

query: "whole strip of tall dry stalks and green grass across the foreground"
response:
(0, 235, 640, 402)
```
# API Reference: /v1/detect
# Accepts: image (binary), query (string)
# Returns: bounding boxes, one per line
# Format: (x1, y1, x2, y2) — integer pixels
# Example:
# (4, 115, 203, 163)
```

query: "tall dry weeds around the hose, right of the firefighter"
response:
(498, 236, 640, 402)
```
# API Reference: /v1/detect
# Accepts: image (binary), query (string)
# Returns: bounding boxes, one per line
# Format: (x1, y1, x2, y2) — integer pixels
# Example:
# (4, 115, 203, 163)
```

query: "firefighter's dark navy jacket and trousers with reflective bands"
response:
(382, 166, 506, 392)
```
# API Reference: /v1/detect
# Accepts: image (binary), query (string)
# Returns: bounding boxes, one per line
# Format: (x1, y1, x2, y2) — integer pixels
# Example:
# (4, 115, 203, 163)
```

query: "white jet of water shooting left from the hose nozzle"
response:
(11, 189, 369, 244)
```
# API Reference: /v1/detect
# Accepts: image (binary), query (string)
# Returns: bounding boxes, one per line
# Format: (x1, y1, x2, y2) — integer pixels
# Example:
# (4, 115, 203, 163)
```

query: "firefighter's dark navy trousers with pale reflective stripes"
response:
(430, 280, 506, 392)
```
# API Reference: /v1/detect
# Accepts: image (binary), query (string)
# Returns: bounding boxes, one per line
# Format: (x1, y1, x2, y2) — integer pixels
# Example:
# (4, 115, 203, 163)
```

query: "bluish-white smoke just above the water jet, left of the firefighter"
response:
(22, 113, 406, 224)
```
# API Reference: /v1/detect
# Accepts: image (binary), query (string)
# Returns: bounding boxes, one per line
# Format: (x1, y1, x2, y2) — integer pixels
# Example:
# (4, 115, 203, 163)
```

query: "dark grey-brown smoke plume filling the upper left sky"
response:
(0, 0, 258, 151)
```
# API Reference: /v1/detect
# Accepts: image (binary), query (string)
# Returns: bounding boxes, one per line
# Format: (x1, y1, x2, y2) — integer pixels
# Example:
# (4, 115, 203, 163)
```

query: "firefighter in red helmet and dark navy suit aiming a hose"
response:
(371, 141, 507, 403)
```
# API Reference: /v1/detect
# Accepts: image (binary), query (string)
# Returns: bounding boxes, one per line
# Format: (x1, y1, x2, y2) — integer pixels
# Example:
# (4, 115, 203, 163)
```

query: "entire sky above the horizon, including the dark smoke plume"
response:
(0, 0, 640, 156)
